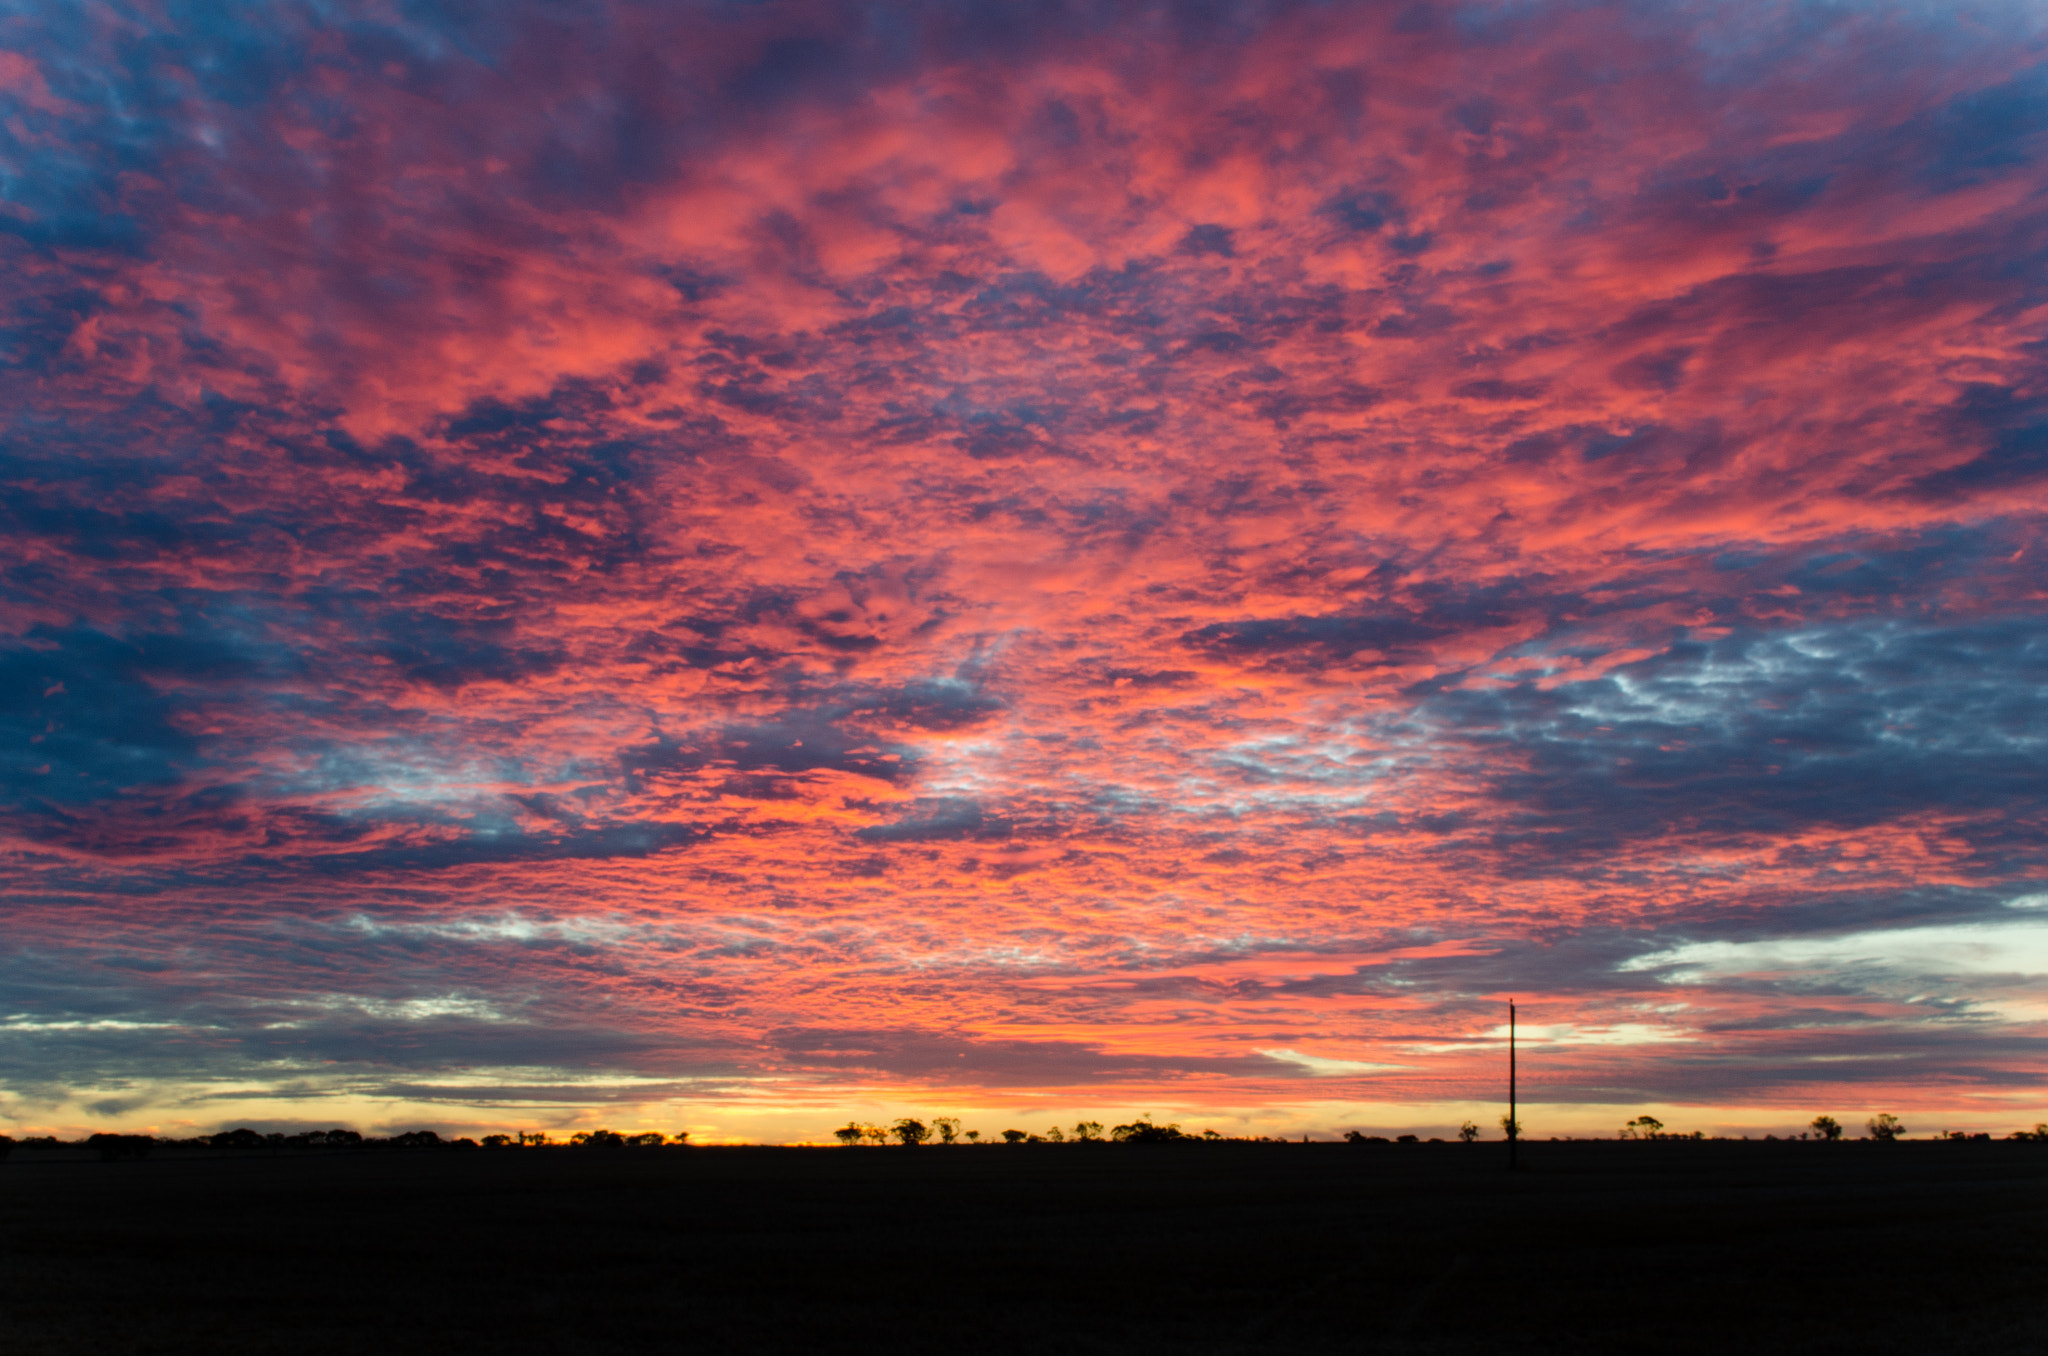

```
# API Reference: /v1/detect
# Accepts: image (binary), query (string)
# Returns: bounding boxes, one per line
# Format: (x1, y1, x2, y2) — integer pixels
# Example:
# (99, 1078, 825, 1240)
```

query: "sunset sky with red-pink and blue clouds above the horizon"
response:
(0, 0, 2048, 1141)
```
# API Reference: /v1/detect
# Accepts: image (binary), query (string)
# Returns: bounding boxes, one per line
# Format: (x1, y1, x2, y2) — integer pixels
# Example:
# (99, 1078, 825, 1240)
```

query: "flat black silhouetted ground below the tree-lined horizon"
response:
(0, 1141, 2048, 1356)
